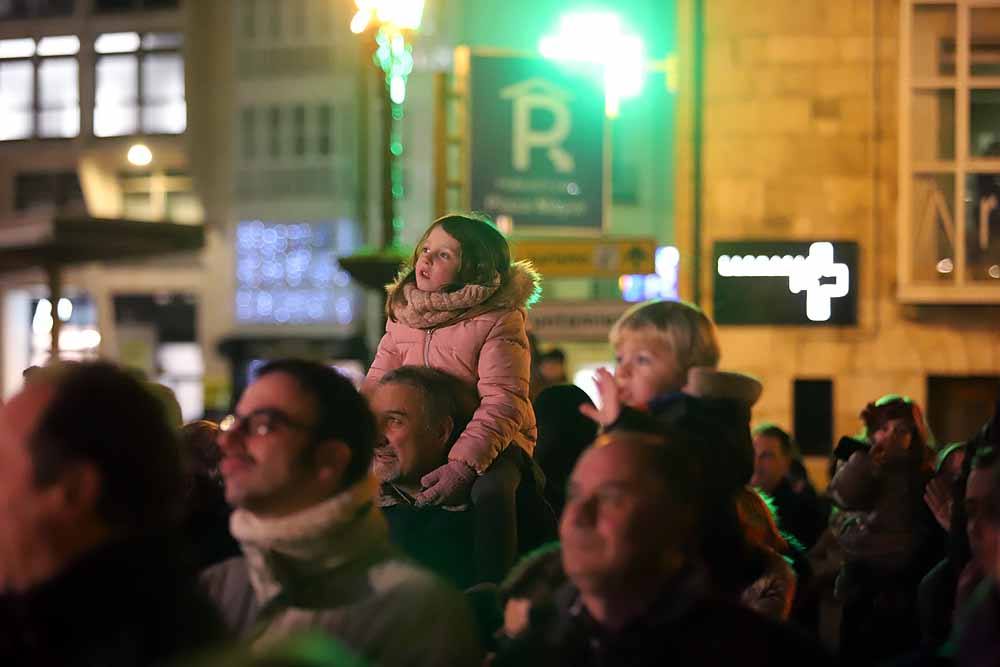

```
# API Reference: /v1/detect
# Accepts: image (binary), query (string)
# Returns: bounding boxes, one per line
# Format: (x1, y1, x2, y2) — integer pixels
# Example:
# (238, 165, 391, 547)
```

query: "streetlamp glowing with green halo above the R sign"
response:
(538, 12, 676, 118)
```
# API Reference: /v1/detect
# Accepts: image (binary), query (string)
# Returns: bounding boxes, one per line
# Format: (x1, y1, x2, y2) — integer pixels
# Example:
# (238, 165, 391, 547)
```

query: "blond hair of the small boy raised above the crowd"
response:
(608, 301, 719, 373)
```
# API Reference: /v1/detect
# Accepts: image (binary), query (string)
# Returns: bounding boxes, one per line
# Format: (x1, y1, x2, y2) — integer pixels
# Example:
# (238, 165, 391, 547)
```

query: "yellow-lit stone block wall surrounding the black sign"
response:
(701, 0, 1000, 464)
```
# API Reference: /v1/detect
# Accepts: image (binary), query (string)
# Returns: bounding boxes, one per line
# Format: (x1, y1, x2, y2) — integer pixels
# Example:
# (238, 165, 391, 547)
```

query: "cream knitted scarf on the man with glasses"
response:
(229, 476, 389, 605)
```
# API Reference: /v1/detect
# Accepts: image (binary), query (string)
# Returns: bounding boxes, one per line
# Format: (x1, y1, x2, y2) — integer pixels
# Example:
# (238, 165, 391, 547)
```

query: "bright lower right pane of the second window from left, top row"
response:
(142, 53, 187, 134)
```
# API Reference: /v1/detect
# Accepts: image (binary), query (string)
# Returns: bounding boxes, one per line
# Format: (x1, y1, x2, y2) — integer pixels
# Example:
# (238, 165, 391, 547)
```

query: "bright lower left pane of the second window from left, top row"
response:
(94, 55, 139, 137)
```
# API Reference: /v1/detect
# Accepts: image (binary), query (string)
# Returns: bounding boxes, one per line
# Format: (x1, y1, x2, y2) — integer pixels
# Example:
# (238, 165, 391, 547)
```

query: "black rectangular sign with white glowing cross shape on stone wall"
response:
(713, 241, 859, 326)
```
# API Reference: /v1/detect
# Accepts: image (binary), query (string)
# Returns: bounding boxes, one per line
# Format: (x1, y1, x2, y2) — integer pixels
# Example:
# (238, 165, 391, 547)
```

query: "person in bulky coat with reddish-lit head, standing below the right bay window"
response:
(828, 395, 941, 664)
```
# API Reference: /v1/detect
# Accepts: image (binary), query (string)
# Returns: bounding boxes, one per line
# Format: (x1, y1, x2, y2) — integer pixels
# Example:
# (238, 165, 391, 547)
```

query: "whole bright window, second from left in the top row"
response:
(94, 32, 187, 137)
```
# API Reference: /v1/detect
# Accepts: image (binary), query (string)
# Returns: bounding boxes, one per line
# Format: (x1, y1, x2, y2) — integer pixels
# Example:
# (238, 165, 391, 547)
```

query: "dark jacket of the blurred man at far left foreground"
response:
(0, 539, 225, 667)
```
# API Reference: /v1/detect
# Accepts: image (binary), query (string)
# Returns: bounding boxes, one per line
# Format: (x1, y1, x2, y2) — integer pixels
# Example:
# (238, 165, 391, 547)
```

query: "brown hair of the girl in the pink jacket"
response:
(385, 214, 510, 321)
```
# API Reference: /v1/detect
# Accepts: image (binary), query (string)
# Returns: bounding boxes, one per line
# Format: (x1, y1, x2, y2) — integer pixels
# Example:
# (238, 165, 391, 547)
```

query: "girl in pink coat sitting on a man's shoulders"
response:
(365, 215, 541, 579)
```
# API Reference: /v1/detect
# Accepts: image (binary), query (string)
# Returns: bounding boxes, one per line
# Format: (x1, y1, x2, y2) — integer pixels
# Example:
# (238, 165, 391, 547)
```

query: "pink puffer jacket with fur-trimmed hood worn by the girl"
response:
(364, 262, 541, 474)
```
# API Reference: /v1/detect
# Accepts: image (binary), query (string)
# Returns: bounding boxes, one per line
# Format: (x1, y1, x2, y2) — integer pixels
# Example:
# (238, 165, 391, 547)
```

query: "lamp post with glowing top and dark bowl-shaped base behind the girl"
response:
(340, 0, 424, 290)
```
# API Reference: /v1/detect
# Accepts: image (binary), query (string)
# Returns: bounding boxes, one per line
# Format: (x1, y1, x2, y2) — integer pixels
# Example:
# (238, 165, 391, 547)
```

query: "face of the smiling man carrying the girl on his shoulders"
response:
(371, 382, 451, 484)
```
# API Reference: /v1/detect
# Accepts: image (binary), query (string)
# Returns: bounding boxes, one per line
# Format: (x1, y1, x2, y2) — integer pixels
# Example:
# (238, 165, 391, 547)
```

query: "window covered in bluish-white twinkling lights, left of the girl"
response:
(236, 220, 359, 326)
